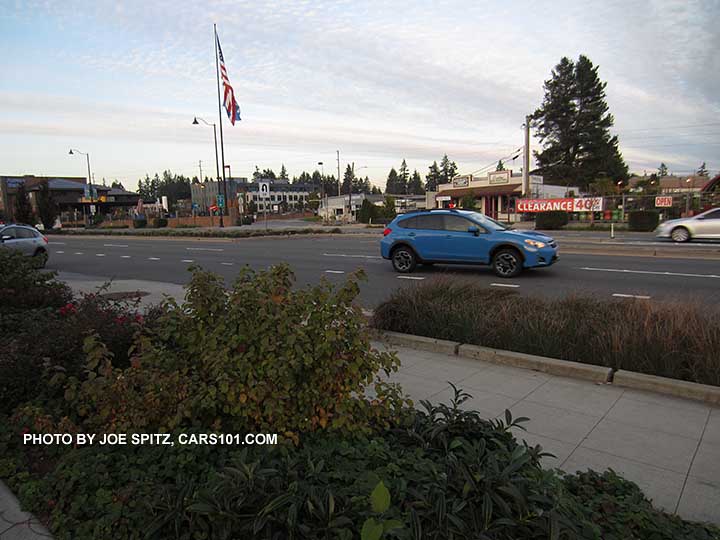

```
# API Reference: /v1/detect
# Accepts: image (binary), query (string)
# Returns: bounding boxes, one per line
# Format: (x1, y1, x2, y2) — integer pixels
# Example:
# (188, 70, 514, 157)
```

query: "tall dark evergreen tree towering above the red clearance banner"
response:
(532, 55, 628, 188)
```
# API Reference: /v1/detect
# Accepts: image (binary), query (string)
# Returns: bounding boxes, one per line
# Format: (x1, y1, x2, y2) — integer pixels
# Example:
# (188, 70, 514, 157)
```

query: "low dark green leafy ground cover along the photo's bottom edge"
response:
(0, 393, 720, 540)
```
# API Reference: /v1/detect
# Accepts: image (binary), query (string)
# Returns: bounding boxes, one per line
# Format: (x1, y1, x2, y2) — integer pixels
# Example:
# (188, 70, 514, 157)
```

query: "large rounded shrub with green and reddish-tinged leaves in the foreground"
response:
(56, 266, 402, 441)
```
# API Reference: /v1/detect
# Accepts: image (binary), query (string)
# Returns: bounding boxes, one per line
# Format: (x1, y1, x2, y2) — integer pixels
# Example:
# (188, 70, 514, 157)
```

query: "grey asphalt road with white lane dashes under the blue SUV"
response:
(48, 235, 720, 308)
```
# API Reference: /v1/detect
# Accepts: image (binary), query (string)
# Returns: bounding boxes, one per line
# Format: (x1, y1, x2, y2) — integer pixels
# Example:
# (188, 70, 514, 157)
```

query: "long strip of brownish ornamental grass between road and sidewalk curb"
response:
(372, 278, 720, 386)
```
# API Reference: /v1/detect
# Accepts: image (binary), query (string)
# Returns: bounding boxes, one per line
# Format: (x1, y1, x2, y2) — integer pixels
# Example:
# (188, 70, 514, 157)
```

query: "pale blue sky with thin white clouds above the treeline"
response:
(0, 0, 720, 189)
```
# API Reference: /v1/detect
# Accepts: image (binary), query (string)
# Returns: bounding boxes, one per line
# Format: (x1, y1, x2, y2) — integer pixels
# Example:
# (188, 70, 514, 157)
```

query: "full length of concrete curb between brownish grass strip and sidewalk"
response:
(370, 328, 720, 405)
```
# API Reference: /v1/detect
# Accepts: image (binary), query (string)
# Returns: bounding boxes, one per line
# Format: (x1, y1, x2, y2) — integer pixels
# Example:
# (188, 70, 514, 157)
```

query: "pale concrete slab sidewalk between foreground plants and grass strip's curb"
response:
(374, 343, 720, 524)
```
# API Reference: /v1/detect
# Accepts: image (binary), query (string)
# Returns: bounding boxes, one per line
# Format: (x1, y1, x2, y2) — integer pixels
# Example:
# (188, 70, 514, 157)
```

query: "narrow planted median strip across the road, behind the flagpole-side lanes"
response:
(45, 227, 342, 238)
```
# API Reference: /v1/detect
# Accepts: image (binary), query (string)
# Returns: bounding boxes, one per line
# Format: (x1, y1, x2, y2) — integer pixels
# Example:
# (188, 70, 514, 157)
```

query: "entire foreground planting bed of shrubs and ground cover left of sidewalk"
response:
(0, 252, 720, 540)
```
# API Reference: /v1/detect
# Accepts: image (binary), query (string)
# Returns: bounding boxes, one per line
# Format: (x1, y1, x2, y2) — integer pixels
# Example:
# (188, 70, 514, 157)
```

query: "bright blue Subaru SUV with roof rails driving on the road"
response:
(380, 208, 558, 278)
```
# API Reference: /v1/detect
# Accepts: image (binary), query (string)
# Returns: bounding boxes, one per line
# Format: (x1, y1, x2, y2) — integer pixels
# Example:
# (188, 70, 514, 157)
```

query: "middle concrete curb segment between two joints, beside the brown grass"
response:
(458, 345, 612, 383)
